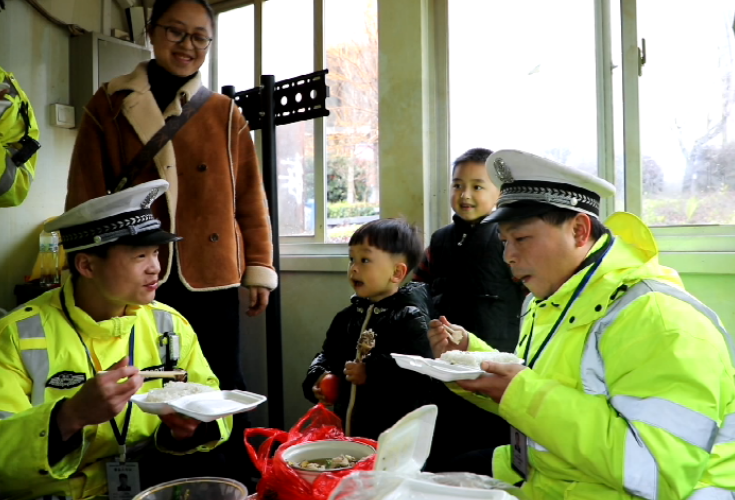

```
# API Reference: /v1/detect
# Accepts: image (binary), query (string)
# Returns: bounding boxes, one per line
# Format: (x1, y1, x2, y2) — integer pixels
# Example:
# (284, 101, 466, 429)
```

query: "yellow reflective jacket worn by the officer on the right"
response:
(457, 214, 735, 500)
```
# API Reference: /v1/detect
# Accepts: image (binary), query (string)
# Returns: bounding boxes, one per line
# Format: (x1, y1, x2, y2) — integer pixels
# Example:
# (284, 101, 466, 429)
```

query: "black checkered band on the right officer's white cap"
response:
(498, 180, 600, 216)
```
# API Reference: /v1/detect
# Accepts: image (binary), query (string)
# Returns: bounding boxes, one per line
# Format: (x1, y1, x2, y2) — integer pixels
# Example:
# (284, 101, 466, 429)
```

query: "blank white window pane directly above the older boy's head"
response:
(449, 0, 597, 174)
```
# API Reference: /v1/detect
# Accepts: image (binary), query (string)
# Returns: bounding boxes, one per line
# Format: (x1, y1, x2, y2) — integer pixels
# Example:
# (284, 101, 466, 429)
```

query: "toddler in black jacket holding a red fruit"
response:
(303, 219, 434, 439)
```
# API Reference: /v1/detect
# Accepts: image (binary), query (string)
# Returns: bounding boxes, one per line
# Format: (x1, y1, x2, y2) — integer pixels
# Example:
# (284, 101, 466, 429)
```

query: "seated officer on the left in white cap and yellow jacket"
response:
(0, 180, 231, 500)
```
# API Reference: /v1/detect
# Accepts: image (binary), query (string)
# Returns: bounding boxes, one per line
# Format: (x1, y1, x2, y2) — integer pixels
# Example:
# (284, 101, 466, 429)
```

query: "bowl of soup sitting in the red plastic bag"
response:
(283, 440, 375, 483)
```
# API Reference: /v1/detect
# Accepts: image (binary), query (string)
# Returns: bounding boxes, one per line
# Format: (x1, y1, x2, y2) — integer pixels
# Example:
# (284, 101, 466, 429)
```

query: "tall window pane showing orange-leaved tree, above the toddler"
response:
(324, 0, 380, 243)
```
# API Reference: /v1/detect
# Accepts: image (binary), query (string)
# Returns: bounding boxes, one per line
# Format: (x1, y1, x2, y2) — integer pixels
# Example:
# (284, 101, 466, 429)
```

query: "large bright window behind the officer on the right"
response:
(447, 0, 735, 234)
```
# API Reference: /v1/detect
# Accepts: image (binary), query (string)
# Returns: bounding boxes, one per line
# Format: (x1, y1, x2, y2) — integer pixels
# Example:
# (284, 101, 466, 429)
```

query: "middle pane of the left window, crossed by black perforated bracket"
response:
(263, 0, 315, 236)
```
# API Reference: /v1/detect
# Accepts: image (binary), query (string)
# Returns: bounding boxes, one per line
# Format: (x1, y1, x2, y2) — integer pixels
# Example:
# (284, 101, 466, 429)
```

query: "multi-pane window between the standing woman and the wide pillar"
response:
(214, 0, 379, 248)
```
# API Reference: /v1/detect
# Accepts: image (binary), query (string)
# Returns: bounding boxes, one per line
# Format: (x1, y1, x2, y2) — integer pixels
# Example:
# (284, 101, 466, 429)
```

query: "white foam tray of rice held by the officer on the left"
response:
(132, 391, 268, 422)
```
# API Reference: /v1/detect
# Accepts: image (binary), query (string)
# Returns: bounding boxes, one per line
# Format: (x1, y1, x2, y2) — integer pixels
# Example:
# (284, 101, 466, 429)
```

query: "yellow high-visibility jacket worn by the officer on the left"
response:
(0, 280, 232, 500)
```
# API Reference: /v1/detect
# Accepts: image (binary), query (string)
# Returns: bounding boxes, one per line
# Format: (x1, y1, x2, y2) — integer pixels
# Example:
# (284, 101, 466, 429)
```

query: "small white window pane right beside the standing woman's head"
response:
(213, 5, 255, 92)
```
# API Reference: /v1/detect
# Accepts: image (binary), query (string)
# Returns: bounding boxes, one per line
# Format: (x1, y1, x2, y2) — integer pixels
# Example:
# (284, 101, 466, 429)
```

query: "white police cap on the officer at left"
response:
(44, 179, 181, 252)
